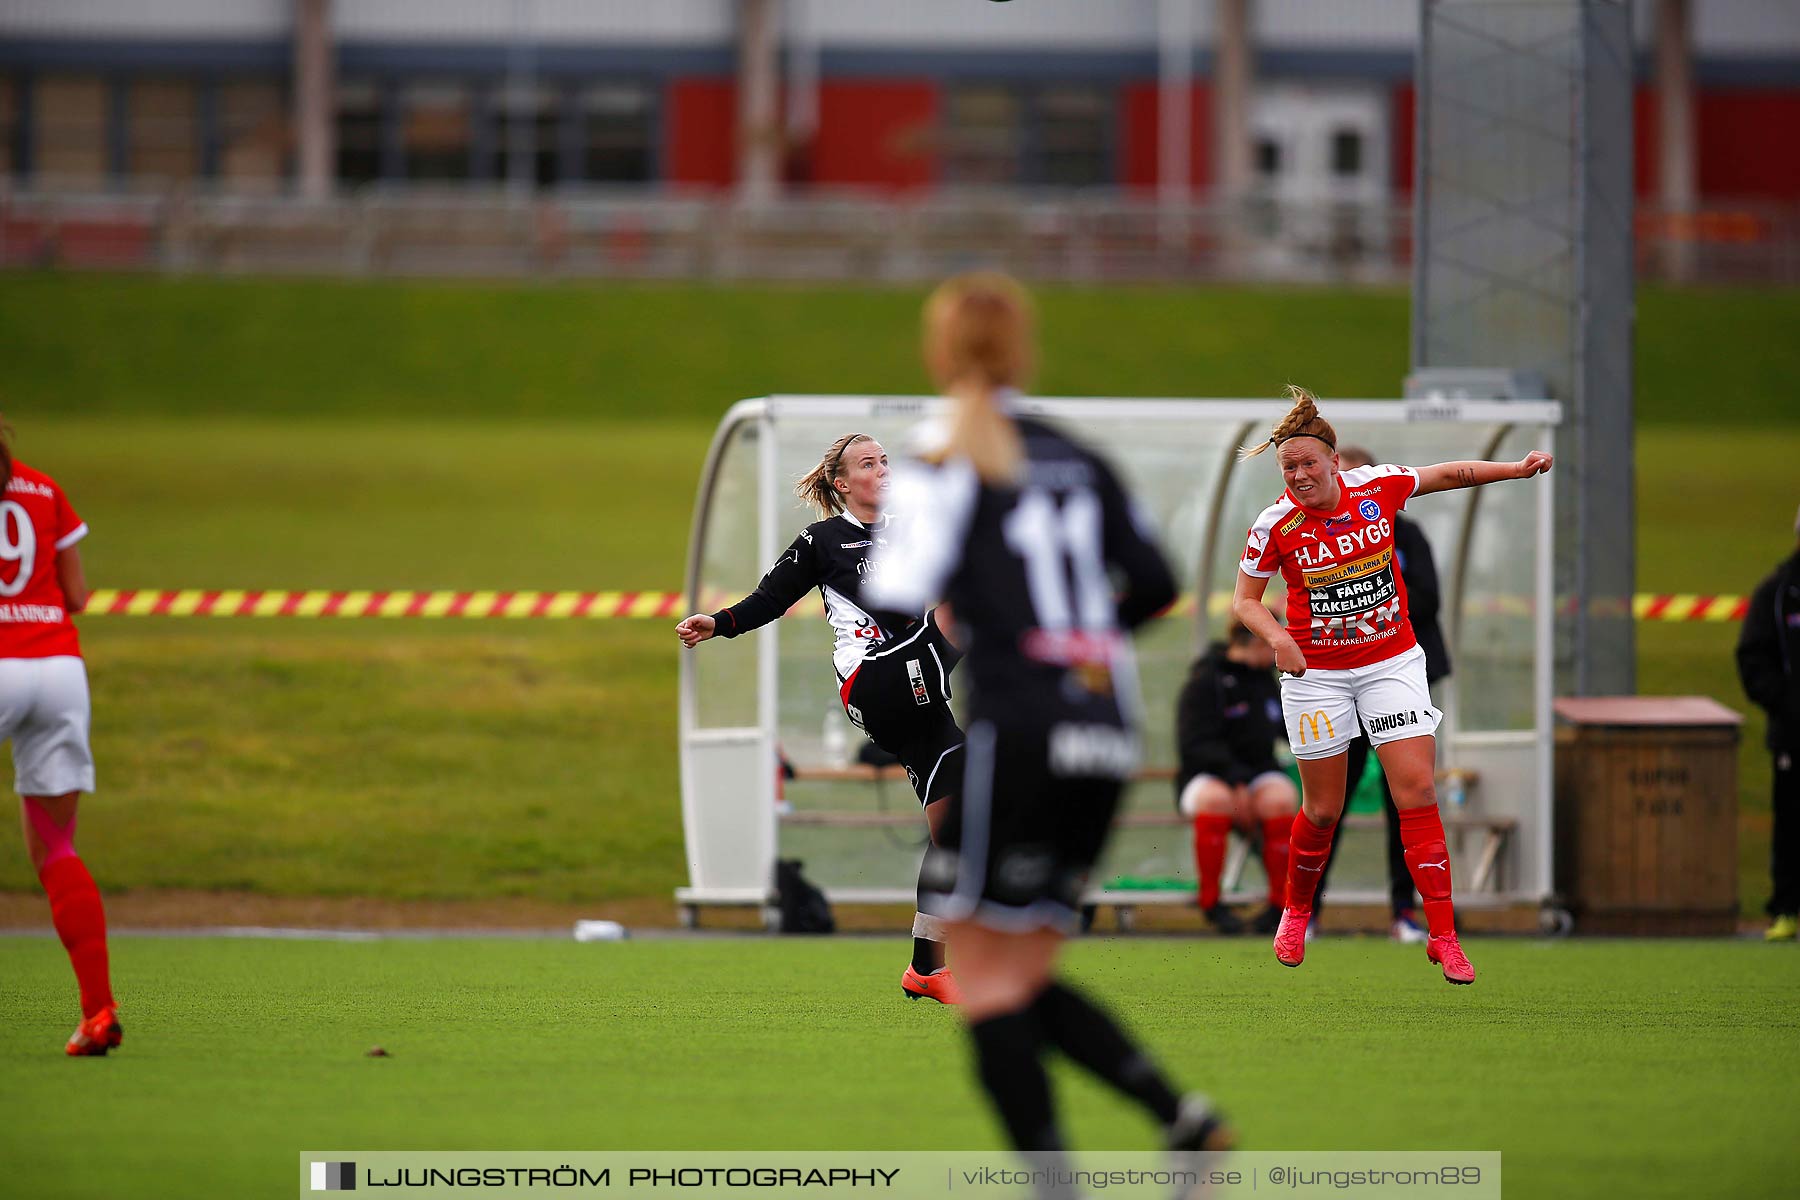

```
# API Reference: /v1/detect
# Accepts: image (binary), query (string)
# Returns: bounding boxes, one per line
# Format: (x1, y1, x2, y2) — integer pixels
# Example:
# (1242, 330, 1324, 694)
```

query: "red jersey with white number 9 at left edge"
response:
(0, 462, 88, 658)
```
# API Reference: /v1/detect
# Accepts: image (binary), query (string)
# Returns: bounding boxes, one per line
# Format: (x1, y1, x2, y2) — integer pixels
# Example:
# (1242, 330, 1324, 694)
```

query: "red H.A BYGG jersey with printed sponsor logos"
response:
(1238, 466, 1418, 671)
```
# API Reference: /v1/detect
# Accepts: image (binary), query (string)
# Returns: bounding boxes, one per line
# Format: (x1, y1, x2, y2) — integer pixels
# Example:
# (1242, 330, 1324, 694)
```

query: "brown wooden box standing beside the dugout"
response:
(1555, 696, 1742, 936)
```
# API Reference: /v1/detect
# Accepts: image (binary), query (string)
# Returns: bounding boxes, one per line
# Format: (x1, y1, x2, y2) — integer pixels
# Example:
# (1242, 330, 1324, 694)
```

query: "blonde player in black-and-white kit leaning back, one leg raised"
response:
(675, 434, 963, 1004)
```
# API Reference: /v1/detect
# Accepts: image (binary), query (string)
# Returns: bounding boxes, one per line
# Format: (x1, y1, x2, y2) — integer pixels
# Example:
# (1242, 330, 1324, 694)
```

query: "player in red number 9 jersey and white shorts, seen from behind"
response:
(0, 422, 124, 1054)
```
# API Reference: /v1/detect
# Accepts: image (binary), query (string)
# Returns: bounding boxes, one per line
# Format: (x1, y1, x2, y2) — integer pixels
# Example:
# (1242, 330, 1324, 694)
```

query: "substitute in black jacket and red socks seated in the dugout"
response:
(1175, 621, 1300, 934)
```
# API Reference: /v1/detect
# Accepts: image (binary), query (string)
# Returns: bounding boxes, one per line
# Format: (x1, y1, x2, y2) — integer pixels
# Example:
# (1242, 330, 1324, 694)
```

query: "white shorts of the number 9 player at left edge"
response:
(0, 655, 94, 795)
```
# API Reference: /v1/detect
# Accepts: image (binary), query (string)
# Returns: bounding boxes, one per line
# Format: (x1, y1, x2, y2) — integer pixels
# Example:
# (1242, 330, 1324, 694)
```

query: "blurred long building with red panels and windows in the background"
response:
(0, 0, 1800, 201)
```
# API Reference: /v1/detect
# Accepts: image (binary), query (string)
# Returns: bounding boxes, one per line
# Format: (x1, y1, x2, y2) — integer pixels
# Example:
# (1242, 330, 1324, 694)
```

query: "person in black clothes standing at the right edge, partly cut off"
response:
(1737, 515, 1800, 941)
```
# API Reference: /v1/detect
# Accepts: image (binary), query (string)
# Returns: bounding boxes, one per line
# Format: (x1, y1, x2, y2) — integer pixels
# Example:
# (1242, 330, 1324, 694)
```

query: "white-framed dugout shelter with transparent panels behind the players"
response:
(675, 396, 1562, 921)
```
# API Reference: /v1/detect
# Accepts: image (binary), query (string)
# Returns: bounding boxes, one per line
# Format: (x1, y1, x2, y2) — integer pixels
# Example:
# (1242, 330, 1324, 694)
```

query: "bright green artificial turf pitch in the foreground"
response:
(0, 937, 1800, 1200)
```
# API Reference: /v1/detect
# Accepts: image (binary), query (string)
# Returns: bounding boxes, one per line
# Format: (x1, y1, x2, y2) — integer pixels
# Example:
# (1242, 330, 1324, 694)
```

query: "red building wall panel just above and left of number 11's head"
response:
(810, 79, 938, 189)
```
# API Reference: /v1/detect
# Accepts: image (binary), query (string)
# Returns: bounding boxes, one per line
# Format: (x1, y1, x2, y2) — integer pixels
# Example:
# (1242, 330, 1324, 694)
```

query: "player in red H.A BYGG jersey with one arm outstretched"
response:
(1231, 387, 1550, 984)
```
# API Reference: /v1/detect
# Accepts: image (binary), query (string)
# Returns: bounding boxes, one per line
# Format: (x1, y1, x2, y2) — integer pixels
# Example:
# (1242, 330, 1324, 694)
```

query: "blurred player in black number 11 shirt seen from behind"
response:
(864, 273, 1229, 1169)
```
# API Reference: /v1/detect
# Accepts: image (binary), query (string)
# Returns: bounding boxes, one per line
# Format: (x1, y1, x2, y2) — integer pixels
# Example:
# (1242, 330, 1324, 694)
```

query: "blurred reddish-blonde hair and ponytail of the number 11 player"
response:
(923, 272, 1035, 484)
